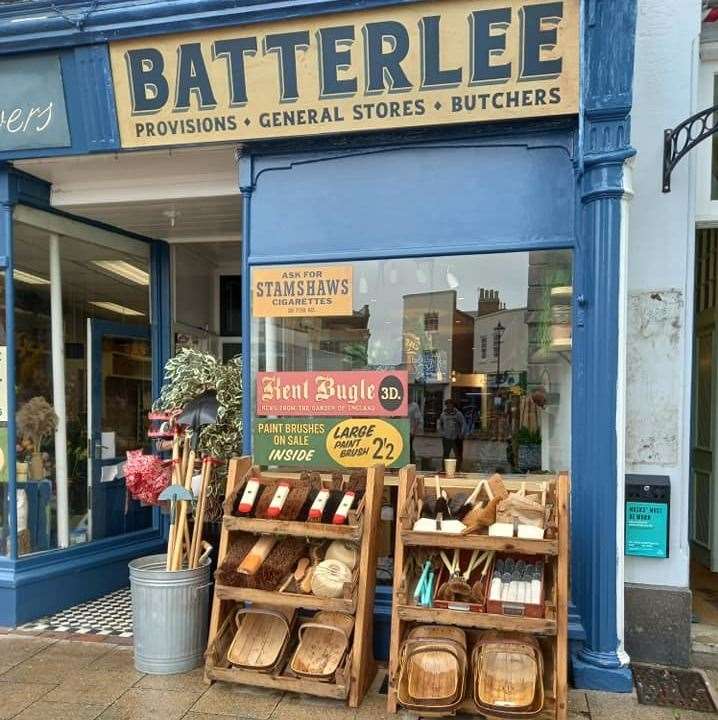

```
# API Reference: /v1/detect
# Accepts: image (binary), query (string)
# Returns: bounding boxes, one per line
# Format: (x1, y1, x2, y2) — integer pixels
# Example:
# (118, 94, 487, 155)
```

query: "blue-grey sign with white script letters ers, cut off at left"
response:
(0, 55, 70, 152)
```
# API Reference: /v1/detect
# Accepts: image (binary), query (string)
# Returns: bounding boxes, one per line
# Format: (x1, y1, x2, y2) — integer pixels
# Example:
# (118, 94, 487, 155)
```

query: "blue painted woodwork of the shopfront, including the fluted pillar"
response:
(0, 0, 635, 690)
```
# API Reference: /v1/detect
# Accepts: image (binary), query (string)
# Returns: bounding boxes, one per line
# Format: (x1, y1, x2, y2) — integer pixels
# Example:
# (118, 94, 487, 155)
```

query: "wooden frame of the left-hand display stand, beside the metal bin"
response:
(205, 457, 384, 707)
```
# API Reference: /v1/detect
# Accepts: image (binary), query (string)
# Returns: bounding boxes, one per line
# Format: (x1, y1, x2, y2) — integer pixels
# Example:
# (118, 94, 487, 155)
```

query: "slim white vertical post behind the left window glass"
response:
(50, 234, 70, 548)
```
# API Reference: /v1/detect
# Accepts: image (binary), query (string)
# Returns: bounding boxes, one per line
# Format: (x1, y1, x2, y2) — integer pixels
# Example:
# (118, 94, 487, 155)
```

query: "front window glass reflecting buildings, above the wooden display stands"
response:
(252, 251, 572, 473)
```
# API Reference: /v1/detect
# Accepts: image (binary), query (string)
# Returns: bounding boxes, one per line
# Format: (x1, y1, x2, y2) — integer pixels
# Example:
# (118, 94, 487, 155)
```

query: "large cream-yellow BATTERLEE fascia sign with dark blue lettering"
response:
(110, 0, 579, 148)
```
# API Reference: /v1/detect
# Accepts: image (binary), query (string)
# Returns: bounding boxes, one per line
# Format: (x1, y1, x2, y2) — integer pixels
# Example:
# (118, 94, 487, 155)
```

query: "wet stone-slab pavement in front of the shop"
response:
(0, 633, 718, 720)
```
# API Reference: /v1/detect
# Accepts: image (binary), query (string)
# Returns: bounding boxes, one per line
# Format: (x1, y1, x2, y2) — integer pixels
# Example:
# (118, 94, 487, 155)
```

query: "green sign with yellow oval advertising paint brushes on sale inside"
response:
(253, 417, 409, 470)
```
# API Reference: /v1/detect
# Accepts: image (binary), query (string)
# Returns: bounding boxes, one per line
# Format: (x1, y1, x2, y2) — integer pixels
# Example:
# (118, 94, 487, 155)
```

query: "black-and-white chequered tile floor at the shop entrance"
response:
(18, 588, 132, 638)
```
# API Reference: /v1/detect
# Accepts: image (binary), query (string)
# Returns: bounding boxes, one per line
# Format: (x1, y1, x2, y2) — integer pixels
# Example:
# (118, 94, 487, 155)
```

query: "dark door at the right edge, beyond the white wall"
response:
(690, 230, 718, 572)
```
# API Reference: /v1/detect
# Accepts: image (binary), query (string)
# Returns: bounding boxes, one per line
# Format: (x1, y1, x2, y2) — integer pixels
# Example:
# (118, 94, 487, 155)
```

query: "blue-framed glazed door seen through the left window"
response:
(87, 319, 152, 540)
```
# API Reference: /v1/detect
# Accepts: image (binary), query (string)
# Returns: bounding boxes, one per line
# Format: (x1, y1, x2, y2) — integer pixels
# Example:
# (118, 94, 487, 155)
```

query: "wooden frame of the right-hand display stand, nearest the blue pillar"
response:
(387, 466, 569, 720)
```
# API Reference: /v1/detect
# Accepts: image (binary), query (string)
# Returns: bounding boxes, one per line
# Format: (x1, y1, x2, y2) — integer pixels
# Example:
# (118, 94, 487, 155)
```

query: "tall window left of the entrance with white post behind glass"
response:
(14, 217, 152, 554)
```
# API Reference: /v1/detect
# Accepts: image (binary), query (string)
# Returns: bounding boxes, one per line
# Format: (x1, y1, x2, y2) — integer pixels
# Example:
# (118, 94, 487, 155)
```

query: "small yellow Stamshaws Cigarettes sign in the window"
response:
(252, 265, 352, 317)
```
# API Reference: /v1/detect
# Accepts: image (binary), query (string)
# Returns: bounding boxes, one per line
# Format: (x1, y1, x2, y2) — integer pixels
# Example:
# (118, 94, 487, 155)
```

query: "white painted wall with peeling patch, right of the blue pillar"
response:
(618, 0, 701, 586)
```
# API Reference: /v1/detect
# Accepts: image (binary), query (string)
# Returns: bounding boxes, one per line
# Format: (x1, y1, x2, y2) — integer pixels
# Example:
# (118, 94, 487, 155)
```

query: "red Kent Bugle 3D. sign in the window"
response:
(257, 370, 408, 417)
